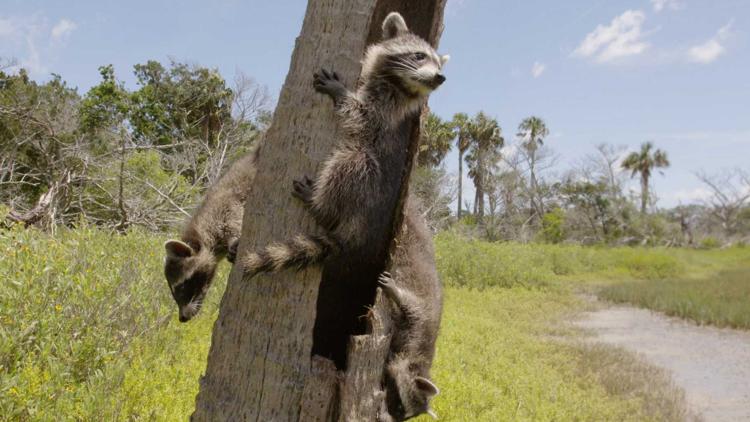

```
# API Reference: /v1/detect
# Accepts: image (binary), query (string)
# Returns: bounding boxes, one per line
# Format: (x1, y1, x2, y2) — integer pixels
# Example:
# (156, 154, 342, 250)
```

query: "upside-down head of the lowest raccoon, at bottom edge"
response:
(379, 357, 440, 422)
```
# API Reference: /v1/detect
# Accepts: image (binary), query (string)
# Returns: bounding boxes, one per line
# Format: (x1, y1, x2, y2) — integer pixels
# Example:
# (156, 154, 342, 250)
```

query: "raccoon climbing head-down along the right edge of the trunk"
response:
(378, 198, 443, 422)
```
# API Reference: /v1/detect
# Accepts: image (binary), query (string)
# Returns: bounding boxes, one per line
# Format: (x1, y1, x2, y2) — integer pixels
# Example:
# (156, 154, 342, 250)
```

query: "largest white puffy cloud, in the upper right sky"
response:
(573, 10, 649, 63)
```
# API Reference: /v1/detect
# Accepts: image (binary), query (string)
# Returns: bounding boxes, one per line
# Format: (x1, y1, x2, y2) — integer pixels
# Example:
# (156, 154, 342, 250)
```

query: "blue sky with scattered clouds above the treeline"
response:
(0, 0, 750, 206)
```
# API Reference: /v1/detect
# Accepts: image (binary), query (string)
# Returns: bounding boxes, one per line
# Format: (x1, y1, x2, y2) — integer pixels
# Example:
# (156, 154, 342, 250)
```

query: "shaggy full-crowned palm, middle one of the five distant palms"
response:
(466, 111, 505, 220)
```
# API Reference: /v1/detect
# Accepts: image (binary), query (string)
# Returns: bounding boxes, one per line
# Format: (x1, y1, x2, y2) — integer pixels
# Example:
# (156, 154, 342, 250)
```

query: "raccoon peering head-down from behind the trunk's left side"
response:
(164, 147, 258, 322)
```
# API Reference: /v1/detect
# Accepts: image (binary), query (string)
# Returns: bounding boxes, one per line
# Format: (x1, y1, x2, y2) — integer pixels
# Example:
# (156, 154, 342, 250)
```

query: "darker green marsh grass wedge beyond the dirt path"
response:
(599, 266, 750, 329)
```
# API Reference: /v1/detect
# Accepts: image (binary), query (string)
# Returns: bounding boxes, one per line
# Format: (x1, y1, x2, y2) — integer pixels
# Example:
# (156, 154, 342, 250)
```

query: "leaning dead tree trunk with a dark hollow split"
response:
(192, 0, 445, 421)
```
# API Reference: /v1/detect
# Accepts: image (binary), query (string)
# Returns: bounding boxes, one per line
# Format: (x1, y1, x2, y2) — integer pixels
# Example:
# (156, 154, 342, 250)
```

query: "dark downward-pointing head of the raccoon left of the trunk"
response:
(164, 240, 216, 322)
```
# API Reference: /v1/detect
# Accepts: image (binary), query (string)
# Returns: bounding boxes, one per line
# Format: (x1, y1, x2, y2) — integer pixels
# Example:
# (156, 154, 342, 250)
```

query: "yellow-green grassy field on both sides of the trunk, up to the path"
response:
(0, 228, 750, 421)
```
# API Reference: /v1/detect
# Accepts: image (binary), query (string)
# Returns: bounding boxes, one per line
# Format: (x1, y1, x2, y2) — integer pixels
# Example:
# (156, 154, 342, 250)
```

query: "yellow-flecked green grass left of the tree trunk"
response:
(0, 223, 226, 421)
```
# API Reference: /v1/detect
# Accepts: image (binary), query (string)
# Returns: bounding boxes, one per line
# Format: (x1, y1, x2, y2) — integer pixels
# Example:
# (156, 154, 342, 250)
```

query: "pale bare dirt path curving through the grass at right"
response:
(576, 300, 750, 422)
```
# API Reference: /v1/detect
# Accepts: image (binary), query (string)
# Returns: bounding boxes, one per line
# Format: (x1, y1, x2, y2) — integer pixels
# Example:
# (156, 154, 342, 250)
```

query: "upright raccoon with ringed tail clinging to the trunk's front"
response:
(242, 12, 448, 276)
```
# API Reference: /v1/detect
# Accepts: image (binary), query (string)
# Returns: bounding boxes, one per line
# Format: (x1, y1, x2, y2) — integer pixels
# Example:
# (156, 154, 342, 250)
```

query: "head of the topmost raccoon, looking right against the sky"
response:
(362, 12, 450, 97)
